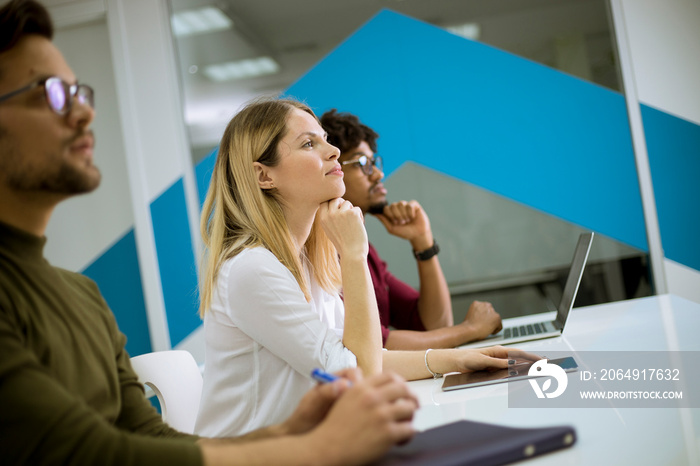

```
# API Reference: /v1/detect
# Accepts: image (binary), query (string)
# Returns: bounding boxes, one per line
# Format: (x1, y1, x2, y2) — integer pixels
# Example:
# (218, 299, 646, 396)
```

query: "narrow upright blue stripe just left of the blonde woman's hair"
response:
(151, 179, 201, 346)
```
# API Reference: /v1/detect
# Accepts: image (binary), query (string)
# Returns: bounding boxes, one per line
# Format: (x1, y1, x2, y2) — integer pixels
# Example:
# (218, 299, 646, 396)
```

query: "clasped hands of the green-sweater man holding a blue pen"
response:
(282, 369, 418, 464)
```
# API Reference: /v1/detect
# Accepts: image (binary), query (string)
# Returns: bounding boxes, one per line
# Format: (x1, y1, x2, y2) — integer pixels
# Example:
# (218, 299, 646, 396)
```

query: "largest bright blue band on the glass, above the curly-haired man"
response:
(287, 10, 648, 250)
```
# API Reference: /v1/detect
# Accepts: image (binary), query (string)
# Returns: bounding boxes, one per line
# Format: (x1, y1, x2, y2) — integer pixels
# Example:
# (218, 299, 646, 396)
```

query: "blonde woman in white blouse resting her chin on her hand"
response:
(196, 100, 507, 437)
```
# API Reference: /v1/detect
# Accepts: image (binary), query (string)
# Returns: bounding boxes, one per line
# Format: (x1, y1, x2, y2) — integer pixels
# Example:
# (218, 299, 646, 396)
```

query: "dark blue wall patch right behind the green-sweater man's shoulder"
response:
(82, 228, 151, 356)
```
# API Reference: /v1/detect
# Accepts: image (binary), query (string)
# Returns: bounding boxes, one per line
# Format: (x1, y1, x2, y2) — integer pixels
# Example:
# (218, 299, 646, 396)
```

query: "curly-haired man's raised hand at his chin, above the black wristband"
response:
(376, 201, 433, 251)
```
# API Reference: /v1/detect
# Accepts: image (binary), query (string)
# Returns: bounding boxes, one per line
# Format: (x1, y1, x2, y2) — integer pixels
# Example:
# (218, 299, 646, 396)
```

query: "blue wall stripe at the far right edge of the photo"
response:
(641, 105, 700, 270)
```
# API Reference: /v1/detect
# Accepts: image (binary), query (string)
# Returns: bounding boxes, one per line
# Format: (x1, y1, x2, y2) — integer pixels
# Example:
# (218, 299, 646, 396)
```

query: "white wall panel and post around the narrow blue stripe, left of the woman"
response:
(106, 0, 200, 350)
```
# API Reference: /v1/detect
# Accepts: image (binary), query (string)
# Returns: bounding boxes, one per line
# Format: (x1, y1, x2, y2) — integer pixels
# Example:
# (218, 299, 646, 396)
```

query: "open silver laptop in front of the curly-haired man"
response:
(460, 232, 594, 348)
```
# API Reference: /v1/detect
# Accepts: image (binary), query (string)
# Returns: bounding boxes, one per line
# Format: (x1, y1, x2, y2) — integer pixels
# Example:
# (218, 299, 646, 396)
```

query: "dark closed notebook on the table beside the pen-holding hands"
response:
(375, 421, 576, 466)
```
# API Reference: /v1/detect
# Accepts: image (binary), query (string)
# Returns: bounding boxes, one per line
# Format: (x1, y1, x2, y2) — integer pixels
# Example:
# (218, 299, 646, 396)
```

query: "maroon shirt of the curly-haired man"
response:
(367, 243, 425, 345)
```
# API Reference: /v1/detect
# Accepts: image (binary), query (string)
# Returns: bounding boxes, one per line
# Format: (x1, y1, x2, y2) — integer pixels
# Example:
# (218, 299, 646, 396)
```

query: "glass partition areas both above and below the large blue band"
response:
(170, 0, 652, 320)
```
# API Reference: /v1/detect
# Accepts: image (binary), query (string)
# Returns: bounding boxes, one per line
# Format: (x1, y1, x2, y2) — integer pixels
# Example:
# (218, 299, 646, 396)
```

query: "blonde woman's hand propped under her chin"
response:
(317, 198, 369, 259)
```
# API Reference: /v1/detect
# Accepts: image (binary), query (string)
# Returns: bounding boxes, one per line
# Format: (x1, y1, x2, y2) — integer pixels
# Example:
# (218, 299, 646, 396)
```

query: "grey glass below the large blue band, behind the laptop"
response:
(367, 163, 651, 322)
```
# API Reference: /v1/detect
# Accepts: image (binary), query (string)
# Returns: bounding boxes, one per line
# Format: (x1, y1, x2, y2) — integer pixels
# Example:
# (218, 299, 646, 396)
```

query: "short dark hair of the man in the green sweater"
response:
(0, 0, 53, 53)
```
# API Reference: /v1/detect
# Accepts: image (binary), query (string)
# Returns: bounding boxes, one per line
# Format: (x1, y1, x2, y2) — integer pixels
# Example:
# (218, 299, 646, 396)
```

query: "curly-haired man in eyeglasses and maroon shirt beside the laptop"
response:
(321, 109, 502, 350)
